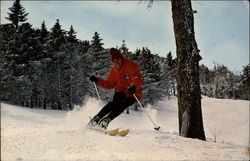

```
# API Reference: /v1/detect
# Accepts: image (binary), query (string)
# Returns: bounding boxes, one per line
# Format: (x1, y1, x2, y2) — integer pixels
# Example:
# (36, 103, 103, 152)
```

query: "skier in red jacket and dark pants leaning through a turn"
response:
(87, 48, 143, 129)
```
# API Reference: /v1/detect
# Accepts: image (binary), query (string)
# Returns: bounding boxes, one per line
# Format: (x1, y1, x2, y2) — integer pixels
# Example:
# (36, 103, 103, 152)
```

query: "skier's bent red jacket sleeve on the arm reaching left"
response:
(97, 68, 116, 89)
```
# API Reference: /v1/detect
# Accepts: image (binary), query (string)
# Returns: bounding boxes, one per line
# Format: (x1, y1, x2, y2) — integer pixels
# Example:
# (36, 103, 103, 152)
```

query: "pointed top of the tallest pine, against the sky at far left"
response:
(5, 0, 28, 29)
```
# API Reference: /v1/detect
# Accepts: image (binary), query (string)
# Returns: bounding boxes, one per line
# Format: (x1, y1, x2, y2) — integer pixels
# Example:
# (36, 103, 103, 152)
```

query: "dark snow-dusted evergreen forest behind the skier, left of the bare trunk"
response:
(0, 20, 177, 109)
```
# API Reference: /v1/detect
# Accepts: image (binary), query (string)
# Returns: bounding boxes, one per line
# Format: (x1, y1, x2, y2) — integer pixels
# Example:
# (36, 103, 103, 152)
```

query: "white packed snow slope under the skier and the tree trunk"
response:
(1, 97, 249, 161)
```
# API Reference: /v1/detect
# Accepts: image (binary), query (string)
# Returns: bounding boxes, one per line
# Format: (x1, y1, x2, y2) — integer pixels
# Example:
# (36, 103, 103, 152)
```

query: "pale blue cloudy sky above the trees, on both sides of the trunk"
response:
(0, 0, 249, 72)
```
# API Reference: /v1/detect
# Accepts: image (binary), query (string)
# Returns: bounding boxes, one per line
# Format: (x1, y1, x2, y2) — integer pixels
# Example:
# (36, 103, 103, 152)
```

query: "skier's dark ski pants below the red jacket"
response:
(97, 92, 135, 120)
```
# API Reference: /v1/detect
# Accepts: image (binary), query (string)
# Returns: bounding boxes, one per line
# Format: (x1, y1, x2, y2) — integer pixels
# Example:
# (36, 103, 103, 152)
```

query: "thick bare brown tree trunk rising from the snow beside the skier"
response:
(172, 0, 206, 140)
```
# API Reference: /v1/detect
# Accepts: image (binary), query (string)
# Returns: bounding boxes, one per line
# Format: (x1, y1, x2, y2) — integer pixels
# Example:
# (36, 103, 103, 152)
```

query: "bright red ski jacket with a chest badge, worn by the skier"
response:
(97, 58, 143, 99)
